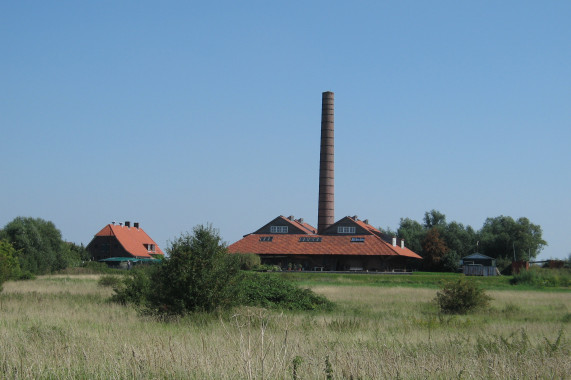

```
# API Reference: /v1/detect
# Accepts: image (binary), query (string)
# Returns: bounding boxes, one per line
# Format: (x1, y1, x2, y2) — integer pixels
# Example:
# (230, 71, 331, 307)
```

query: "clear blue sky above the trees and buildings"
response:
(0, 0, 571, 258)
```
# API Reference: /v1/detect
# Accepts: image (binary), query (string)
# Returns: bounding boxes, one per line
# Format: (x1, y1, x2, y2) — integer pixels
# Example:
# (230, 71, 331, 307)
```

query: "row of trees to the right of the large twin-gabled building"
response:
(383, 210, 547, 271)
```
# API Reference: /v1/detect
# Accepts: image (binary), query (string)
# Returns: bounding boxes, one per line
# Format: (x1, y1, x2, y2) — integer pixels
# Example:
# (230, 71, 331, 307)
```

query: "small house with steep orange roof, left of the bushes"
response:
(86, 222, 164, 261)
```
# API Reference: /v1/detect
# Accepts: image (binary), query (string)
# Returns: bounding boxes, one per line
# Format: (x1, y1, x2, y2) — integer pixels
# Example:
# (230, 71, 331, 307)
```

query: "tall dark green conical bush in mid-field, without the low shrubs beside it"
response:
(148, 225, 240, 314)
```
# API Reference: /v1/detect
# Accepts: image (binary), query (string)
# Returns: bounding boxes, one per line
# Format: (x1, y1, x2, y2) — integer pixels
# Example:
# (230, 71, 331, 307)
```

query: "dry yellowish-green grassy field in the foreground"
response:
(0, 274, 571, 379)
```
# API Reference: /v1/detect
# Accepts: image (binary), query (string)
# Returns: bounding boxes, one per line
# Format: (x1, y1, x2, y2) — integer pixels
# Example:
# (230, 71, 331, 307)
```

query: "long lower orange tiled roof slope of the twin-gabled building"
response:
(228, 234, 422, 259)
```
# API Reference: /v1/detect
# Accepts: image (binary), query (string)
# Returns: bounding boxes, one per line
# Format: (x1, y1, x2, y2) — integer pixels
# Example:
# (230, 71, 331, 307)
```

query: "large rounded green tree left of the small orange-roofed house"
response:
(2, 217, 79, 274)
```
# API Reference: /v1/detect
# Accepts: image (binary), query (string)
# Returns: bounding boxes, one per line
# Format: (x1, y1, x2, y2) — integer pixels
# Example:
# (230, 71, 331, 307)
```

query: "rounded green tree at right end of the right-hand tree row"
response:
(480, 215, 547, 260)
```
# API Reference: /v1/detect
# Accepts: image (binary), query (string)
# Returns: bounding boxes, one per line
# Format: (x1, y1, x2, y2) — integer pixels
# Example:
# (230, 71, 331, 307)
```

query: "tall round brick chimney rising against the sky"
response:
(317, 91, 335, 234)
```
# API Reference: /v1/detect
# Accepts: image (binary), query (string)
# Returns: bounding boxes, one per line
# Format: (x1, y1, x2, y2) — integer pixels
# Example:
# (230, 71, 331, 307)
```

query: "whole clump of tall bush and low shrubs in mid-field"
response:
(111, 225, 332, 315)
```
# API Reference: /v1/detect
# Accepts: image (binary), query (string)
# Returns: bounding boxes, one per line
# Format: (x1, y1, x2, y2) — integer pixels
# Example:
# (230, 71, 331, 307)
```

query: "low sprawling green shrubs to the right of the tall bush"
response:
(240, 272, 333, 310)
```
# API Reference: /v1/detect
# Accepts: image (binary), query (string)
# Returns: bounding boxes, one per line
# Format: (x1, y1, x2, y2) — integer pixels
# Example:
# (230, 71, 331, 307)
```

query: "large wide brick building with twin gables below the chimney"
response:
(228, 216, 422, 272)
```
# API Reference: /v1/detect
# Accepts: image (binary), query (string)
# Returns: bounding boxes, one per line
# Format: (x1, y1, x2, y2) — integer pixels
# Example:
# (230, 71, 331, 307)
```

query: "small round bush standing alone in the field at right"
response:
(435, 278, 491, 314)
